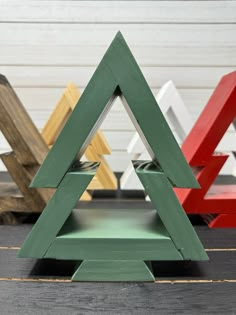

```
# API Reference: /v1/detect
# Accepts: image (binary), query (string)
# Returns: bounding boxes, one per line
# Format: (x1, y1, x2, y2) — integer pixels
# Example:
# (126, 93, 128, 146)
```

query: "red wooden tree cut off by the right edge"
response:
(176, 71, 236, 227)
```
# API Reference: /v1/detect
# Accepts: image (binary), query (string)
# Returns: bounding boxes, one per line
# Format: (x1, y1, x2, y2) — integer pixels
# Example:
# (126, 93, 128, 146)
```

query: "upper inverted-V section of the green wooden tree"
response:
(31, 32, 199, 187)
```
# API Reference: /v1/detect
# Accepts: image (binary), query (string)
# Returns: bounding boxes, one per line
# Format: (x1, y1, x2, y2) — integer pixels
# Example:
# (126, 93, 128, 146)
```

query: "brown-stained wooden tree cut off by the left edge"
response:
(0, 75, 53, 212)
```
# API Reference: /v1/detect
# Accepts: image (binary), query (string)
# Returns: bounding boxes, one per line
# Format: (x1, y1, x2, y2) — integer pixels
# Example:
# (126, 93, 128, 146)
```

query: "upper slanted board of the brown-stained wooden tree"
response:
(0, 75, 48, 165)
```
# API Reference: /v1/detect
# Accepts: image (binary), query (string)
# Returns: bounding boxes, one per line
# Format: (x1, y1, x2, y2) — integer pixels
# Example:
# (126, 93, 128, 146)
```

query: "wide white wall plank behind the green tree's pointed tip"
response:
(0, 23, 236, 66)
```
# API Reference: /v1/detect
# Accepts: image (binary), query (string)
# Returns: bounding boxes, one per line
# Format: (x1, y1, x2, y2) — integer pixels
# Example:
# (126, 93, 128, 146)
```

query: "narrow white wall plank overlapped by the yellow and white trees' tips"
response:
(0, 66, 235, 88)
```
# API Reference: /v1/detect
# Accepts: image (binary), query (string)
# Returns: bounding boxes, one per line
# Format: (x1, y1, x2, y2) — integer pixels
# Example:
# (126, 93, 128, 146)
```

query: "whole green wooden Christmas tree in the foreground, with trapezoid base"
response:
(19, 32, 208, 281)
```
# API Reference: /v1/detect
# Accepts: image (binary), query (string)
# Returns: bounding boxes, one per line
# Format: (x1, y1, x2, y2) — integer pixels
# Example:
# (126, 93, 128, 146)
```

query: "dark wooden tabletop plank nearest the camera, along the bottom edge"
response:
(0, 281, 236, 315)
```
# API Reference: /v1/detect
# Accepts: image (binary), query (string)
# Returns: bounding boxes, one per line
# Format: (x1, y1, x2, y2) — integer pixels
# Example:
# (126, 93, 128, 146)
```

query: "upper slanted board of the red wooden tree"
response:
(182, 71, 236, 166)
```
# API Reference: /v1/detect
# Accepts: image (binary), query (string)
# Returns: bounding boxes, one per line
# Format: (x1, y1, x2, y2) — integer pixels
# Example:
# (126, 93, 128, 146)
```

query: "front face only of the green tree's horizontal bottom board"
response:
(44, 239, 183, 260)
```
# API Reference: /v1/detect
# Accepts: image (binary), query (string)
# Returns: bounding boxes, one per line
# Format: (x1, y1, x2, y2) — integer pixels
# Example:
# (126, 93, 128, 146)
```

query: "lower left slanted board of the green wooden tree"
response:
(18, 162, 99, 258)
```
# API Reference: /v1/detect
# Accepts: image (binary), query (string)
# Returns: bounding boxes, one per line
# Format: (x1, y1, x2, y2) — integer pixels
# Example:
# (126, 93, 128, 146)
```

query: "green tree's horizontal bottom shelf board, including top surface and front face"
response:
(42, 209, 183, 260)
